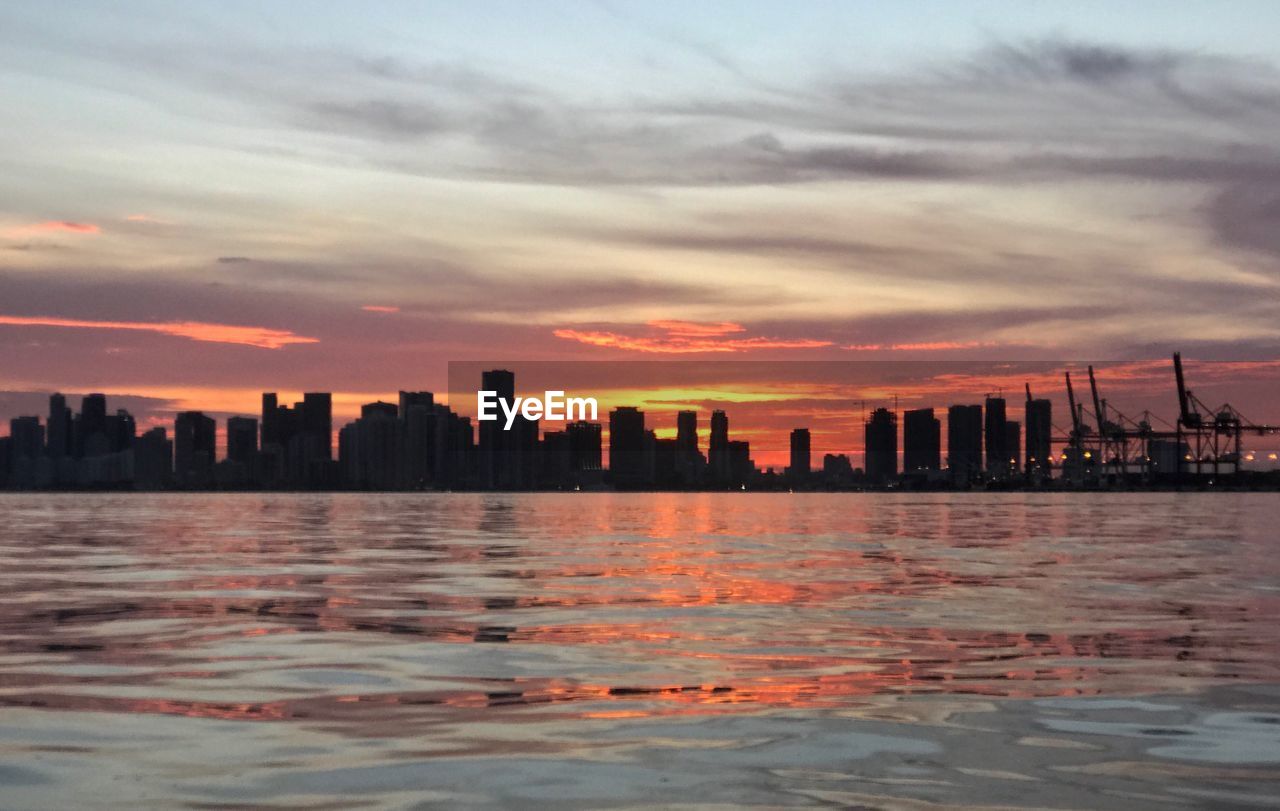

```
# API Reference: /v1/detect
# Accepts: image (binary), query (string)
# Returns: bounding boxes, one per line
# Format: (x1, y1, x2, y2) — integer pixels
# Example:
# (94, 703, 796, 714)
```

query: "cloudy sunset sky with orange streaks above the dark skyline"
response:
(0, 0, 1280, 442)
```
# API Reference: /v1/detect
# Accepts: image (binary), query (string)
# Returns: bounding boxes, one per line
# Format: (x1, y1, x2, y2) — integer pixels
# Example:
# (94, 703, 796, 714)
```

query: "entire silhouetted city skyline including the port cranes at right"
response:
(0, 353, 1280, 490)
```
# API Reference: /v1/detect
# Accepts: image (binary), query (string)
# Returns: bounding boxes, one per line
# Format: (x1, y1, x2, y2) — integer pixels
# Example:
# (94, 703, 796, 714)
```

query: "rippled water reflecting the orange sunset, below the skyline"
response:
(0, 494, 1280, 810)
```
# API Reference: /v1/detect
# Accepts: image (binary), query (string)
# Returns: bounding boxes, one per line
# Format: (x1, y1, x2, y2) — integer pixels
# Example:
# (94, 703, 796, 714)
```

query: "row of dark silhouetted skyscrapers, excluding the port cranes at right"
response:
(0, 370, 1051, 490)
